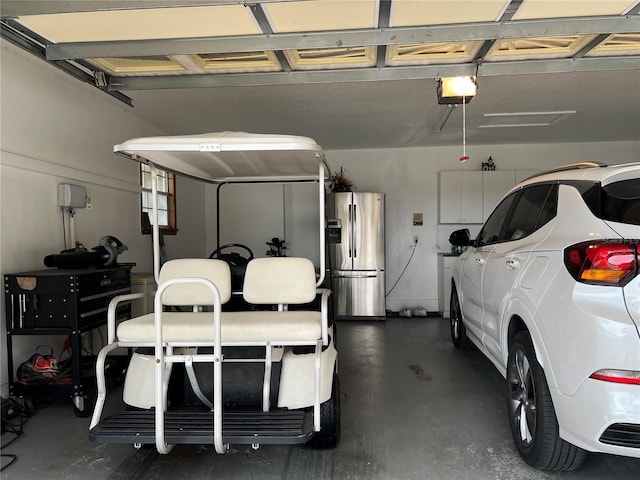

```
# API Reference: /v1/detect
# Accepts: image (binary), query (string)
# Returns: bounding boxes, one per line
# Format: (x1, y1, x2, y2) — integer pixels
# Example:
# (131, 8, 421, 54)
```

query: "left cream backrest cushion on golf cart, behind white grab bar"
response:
(160, 258, 231, 306)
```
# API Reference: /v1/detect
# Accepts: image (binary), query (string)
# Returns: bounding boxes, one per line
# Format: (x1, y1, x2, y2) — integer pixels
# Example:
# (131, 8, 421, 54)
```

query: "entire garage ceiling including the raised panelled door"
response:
(0, 0, 640, 149)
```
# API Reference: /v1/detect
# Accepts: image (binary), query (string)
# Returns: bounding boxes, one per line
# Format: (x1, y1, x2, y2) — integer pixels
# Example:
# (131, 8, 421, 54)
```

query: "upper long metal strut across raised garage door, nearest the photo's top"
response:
(47, 15, 640, 60)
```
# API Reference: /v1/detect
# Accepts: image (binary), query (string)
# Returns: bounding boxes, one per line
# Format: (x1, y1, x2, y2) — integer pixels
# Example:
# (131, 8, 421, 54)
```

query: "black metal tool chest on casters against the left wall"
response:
(4, 264, 134, 416)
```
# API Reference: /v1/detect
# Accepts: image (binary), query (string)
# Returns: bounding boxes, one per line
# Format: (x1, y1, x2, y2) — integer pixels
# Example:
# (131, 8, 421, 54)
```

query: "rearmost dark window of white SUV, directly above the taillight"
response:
(578, 178, 640, 225)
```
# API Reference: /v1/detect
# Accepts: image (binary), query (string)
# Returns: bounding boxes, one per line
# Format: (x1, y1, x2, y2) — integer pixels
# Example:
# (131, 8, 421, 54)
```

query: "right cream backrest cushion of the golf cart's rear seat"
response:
(242, 257, 316, 305)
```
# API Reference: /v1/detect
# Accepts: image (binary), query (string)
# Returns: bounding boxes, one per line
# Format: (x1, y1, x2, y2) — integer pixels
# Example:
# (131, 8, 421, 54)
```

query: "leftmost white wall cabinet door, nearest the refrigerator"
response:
(440, 171, 482, 223)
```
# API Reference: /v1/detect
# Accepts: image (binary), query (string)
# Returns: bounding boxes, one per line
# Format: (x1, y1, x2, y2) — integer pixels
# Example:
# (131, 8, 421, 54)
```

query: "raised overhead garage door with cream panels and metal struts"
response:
(0, 0, 640, 100)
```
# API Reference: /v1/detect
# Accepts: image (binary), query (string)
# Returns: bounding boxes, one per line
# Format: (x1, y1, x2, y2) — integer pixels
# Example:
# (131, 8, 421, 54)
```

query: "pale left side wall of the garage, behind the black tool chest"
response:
(0, 40, 205, 396)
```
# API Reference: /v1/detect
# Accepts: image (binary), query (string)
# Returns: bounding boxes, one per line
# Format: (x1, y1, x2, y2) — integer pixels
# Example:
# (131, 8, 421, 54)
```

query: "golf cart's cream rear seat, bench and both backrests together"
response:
(117, 257, 322, 343)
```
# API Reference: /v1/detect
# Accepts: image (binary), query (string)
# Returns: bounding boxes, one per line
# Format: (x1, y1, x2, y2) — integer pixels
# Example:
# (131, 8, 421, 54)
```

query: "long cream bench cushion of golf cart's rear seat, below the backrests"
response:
(118, 311, 322, 344)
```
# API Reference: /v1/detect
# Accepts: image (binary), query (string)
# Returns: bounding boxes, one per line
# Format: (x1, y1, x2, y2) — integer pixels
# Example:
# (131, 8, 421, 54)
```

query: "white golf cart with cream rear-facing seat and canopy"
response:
(89, 132, 340, 453)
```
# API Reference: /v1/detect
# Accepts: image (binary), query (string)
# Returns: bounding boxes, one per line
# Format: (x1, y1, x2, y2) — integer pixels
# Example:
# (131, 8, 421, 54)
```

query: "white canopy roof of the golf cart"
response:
(113, 132, 329, 183)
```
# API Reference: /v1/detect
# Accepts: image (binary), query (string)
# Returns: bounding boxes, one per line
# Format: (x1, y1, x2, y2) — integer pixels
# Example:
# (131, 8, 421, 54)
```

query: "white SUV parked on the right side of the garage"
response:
(450, 163, 640, 470)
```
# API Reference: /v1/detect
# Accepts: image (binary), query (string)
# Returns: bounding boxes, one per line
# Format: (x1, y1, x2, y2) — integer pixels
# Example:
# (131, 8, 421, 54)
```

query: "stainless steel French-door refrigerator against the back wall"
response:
(327, 192, 386, 319)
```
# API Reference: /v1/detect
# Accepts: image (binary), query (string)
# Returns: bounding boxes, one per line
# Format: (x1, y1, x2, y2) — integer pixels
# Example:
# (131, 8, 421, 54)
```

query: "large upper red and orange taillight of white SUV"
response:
(564, 240, 640, 286)
